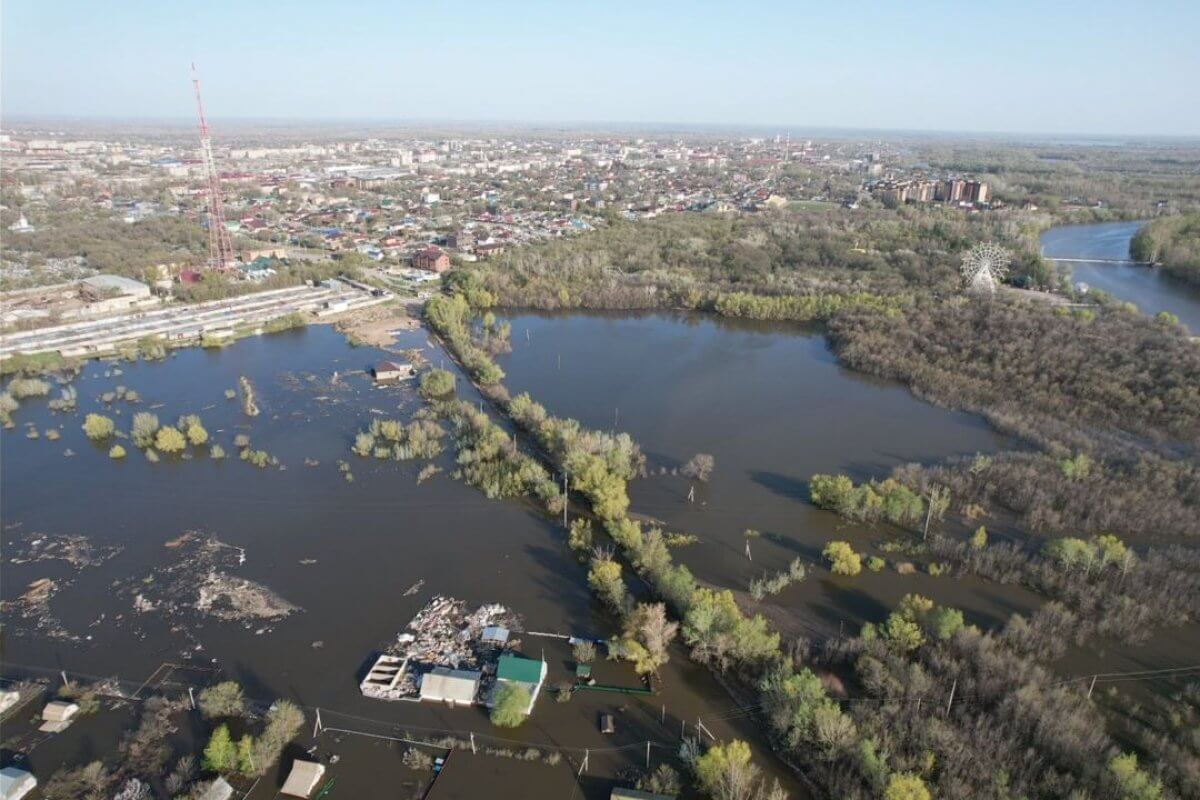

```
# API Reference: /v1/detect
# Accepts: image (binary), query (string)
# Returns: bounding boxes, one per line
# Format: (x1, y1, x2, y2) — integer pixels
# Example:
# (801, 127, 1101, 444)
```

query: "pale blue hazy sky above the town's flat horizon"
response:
(0, 0, 1200, 136)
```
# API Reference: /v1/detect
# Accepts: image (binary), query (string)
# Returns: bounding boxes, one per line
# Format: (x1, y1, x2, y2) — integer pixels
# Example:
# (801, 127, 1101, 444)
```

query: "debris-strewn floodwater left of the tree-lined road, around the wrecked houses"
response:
(0, 326, 800, 796)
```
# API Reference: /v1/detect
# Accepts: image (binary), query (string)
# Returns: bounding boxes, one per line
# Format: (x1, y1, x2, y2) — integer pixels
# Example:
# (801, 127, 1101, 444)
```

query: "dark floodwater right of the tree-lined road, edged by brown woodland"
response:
(500, 314, 1039, 634)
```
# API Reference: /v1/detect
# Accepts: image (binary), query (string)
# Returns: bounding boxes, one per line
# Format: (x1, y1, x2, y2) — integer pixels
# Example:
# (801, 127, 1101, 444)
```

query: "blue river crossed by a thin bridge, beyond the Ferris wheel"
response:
(1042, 222, 1200, 333)
